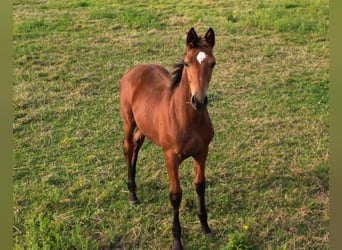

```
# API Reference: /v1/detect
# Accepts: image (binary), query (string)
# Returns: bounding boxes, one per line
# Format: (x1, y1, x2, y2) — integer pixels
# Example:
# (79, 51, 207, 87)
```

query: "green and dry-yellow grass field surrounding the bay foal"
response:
(13, 0, 329, 249)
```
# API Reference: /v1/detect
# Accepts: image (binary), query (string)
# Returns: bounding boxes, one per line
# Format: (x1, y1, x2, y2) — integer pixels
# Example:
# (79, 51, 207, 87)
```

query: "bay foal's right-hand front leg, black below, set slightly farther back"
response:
(194, 149, 211, 235)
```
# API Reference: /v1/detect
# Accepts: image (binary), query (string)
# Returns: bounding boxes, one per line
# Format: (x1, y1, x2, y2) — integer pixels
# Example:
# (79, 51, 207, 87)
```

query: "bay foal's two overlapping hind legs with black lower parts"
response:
(124, 119, 145, 204)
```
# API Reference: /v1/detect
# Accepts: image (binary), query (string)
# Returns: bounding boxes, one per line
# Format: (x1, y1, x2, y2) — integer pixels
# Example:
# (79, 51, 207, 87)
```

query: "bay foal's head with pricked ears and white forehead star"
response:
(183, 28, 215, 110)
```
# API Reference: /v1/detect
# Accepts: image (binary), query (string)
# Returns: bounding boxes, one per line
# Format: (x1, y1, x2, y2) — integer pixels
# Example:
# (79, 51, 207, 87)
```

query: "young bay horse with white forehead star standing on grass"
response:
(120, 28, 215, 249)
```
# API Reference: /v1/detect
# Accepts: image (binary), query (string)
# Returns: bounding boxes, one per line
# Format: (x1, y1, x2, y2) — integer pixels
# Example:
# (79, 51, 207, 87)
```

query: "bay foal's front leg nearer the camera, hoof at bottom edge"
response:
(164, 152, 183, 250)
